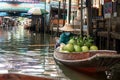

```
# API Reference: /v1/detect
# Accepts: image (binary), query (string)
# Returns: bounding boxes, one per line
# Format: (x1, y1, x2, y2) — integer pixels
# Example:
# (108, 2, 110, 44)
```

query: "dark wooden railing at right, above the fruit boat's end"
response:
(93, 17, 120, 51)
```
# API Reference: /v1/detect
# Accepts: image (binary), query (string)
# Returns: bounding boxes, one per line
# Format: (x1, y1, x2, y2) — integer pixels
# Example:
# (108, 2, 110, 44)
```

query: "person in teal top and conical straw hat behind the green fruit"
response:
(55, 23, 74, 48)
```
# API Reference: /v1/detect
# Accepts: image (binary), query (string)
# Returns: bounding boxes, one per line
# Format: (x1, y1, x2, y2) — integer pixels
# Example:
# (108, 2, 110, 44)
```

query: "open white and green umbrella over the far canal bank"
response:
(28, 7, 48, 15)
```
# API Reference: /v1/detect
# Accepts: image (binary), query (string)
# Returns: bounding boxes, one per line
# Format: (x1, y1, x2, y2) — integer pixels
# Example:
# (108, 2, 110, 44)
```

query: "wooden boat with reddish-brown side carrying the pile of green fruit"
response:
(54, 48, 120, 73)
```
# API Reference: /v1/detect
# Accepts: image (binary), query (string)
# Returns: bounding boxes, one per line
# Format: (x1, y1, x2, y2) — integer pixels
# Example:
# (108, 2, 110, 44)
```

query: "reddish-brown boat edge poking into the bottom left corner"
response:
(0, 73, 54, 80)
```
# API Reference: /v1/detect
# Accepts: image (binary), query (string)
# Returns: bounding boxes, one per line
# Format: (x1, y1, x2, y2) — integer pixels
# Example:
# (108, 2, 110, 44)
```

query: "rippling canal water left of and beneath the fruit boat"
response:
(0, 26, 115, 80)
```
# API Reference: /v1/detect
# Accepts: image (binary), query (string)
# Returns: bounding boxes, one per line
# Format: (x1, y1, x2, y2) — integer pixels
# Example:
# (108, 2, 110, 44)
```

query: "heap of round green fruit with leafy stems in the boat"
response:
(58, 35, 98, 52)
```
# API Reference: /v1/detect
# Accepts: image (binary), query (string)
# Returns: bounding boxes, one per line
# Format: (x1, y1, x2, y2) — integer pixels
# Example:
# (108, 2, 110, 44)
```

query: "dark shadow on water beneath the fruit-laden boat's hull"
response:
(56, 61, 120, 80)
